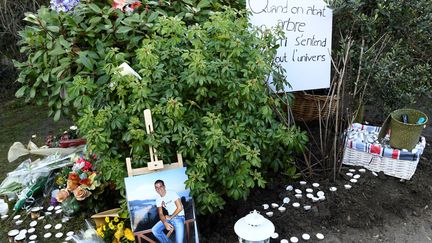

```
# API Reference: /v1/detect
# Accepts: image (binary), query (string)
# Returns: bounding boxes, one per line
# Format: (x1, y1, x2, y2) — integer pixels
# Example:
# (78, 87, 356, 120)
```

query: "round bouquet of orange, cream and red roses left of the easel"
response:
(56, 155, 100, 203)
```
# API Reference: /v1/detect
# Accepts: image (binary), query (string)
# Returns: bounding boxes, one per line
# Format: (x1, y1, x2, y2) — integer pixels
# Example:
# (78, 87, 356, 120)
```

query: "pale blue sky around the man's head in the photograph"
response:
(125, 167, 189, 201)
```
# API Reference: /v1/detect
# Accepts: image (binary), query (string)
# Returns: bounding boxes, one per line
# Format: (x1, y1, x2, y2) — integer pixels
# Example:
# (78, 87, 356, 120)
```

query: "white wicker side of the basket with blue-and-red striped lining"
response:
(342, 147, 420, 180)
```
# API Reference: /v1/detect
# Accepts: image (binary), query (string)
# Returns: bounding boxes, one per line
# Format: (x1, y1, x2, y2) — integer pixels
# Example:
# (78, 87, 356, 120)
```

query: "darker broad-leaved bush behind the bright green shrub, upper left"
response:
(15, 0, 246, 120)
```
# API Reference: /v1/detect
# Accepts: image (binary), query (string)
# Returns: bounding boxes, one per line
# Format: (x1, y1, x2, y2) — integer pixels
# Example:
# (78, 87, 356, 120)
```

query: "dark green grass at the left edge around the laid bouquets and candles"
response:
(0, 100, 89, 242)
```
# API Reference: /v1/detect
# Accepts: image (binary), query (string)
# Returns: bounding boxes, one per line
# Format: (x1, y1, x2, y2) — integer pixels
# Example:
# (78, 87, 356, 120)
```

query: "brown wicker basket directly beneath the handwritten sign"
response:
(291, 93, 338, 122)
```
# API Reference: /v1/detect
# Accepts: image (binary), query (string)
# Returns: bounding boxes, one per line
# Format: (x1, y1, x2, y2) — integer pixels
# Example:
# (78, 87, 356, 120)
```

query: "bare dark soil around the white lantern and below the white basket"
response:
(198, 126, 432, 243)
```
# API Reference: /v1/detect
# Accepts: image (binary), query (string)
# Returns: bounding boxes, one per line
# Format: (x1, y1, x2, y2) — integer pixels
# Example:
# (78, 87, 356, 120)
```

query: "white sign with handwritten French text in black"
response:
(246, 0, 333, 91)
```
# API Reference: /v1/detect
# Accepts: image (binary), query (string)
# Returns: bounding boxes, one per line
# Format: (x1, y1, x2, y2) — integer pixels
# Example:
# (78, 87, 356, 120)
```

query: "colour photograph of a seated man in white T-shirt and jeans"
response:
(125, 167, 199, 243)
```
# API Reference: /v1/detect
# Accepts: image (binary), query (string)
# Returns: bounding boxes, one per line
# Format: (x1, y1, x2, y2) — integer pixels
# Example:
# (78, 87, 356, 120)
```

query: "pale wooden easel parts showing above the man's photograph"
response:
(126, 109, 183, 176)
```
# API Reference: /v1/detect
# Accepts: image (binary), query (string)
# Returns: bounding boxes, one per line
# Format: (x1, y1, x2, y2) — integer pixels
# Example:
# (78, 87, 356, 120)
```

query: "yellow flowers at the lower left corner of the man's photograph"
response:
(96, 217, 135, 243)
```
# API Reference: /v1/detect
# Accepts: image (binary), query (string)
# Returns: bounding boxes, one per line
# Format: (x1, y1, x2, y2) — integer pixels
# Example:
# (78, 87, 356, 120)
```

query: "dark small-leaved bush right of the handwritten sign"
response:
(331, 0, 432, 117)
